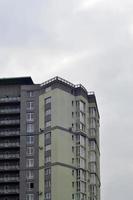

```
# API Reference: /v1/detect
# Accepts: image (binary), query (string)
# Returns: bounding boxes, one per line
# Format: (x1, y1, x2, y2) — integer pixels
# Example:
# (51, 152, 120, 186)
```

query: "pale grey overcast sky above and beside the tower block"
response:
(0, 0, 133, 200)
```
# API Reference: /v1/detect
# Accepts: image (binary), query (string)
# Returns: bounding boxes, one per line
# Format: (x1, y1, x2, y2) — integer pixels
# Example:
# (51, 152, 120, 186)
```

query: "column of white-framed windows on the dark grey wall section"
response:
(26, 91, 35, 200)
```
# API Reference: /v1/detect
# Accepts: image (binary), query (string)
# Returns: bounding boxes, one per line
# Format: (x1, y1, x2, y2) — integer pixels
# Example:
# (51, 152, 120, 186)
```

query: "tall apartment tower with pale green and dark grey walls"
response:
(0, 77, 100, 200)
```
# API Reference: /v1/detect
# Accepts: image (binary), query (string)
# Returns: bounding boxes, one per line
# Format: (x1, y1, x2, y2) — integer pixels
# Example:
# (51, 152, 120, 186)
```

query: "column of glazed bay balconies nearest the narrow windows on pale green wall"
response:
(76, 101, 87, 200)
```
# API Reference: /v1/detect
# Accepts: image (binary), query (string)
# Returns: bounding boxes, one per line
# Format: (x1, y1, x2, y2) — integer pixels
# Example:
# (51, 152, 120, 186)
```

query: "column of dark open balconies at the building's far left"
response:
(0, 97, 20, 200)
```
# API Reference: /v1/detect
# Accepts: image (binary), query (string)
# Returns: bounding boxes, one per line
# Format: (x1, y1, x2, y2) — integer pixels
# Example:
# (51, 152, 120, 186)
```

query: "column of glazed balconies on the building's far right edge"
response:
(89, 105, 100, 200)
